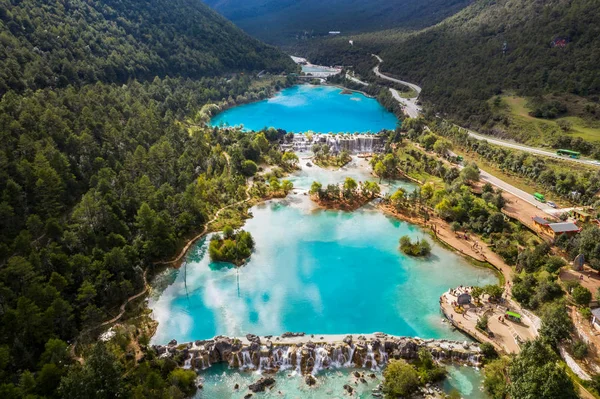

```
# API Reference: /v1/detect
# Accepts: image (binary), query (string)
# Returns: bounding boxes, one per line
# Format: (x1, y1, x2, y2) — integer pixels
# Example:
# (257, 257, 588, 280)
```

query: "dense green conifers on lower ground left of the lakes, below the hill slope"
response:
(0, 77, 290, 396)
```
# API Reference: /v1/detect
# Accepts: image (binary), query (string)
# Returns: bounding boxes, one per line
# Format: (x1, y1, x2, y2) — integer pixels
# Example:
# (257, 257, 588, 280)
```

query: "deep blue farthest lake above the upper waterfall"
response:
(210, 85, 398, 133)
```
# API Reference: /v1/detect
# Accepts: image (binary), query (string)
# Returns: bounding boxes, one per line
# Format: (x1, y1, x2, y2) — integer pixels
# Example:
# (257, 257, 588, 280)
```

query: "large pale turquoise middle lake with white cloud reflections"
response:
(149, 162, 497, 344)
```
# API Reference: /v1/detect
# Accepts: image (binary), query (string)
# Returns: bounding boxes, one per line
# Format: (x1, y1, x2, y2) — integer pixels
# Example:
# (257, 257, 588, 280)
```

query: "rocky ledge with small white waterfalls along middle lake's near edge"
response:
(153, 333, 482, 375)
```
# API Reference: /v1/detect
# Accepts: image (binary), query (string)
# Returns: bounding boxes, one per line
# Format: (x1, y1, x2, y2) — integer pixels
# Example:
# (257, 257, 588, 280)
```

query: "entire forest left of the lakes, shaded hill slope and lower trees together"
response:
(0, 0, 296, 399)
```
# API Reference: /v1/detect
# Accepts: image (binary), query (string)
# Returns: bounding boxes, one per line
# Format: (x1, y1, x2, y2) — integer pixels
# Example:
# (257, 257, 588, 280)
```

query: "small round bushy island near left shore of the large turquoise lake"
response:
(208, 226, 254, 266)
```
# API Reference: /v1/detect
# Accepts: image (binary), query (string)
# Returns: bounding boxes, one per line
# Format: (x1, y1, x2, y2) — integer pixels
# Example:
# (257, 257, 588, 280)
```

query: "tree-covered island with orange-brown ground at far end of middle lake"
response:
(310, 177, 381, 211)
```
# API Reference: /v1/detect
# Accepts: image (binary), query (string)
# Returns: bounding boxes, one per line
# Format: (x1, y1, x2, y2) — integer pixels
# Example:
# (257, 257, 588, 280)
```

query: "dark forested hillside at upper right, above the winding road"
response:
(305, 0, 600, 127)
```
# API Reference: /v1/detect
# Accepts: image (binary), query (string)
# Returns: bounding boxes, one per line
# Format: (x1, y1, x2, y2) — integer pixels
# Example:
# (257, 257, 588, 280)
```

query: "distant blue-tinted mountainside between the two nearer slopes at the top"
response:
(206, 0, 472, 45)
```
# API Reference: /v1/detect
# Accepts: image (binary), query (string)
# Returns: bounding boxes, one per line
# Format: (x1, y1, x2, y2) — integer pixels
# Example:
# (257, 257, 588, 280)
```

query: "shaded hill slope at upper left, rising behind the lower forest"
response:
(0, 0, 294, 95)
